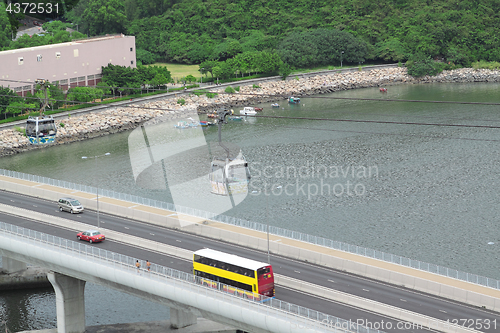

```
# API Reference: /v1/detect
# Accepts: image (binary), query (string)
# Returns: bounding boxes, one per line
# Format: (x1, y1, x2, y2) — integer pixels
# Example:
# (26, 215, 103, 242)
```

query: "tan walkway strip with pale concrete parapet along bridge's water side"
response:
(0, 176, 500, 311)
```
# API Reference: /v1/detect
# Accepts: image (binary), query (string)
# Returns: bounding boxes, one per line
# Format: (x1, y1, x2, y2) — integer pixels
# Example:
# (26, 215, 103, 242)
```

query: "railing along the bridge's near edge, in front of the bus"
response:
(0, 222, 383, 333)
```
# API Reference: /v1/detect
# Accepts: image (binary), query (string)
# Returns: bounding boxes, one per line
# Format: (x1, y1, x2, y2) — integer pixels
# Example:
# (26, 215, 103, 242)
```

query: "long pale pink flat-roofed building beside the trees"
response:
(0, 35, 136, 96)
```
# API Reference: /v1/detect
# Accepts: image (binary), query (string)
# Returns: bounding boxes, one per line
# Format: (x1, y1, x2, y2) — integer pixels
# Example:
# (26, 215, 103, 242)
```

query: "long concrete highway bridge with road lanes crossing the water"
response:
(0, 171, 500, 332)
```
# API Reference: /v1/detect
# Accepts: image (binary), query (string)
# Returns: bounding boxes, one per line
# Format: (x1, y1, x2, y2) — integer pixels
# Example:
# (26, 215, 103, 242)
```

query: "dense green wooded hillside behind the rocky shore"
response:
(0, 0, 500, 67)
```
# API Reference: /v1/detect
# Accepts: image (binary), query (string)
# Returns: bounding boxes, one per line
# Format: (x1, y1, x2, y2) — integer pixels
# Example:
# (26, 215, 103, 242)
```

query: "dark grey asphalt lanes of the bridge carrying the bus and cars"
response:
(0, 191, 500, 332)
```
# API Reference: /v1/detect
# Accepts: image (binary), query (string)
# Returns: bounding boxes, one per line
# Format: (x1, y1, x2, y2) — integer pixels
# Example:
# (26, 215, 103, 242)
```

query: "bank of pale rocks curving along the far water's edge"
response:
(0, 67, 500, 156)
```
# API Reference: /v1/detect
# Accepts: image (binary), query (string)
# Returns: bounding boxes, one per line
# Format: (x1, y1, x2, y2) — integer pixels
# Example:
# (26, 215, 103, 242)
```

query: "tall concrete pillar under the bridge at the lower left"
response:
(47, 272, 85, 333)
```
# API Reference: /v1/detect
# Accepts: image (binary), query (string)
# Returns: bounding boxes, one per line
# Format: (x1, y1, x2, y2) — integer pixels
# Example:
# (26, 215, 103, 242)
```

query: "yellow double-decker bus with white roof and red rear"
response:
(193, 249, 274, 300)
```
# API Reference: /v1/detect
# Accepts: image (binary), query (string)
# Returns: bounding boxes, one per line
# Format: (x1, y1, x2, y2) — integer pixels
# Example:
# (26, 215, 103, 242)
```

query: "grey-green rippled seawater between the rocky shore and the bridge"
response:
(0, 83, 500, 329)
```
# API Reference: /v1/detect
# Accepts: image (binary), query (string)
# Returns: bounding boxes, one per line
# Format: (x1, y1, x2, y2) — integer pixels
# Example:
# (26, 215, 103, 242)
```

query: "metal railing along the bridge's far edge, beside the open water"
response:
(0, 169, 500, 290)
